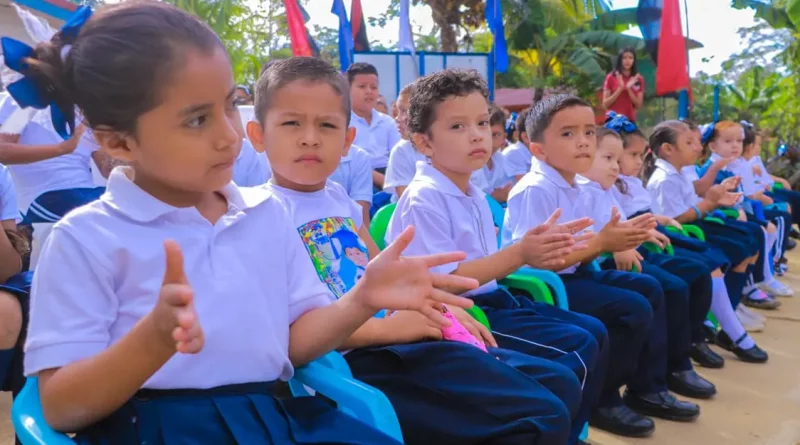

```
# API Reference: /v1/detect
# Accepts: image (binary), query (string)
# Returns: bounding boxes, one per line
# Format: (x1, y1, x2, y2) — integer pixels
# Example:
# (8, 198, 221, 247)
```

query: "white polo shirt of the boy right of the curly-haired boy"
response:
(501, 162, 591, 273)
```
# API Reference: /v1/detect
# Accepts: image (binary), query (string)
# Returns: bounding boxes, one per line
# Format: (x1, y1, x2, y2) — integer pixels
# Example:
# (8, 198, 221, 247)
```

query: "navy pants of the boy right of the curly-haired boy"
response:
(561, 269, 667, 406)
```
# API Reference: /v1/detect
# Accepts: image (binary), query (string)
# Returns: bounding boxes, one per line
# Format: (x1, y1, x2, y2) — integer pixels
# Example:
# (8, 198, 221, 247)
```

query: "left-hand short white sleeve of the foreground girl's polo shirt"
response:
(24, 225, 119, 375)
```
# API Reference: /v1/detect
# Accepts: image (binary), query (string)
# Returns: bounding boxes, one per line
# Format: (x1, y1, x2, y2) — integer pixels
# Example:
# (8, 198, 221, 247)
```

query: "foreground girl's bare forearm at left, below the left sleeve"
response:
(39, 316, 175, 432)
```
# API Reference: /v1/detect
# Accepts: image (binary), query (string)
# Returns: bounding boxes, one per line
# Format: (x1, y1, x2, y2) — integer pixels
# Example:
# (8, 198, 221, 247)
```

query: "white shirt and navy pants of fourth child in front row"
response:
(502, 162, 667, 416)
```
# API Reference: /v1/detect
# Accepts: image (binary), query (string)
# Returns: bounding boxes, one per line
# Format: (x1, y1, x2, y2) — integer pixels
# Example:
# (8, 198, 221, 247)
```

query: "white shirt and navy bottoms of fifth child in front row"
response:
(577, 178, 711, 373)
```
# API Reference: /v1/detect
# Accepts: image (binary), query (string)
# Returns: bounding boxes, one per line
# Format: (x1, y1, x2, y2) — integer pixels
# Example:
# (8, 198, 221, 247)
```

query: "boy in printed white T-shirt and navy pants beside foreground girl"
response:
(248, 58, 580, 445)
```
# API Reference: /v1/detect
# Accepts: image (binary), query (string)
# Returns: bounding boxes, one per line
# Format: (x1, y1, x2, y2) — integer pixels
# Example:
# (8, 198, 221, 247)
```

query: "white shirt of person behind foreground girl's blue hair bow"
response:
(0, 96, 100, 214)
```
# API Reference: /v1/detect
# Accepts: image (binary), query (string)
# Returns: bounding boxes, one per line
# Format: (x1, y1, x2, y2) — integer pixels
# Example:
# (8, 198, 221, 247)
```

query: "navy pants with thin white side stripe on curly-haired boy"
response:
(471, 289, 608, 443)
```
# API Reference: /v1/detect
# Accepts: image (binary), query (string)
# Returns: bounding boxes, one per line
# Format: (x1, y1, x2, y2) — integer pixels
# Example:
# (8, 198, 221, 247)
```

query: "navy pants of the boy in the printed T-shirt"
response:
(345, 341, 581, 445)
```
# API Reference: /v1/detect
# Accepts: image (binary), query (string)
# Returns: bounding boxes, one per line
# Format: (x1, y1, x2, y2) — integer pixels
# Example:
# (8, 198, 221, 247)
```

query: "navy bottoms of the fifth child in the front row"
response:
(641, 249, 716, 364)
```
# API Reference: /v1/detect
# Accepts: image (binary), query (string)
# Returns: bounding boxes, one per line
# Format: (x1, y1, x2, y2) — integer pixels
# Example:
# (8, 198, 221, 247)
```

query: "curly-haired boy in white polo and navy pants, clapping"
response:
(386, 69, 607, 443)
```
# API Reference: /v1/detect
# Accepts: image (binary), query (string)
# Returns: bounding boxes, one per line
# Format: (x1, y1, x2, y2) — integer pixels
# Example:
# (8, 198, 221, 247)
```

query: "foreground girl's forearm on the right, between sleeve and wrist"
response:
(289, 290, 375, 367)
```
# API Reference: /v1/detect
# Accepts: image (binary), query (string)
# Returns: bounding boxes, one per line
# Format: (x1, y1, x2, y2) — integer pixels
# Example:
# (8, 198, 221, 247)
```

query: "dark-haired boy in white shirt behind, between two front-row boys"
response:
(347, 62, 401, 189)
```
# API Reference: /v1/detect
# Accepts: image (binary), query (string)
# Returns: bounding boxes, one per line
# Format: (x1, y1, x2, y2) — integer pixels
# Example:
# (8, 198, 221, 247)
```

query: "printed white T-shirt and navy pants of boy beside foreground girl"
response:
(265, 181, 580, 445)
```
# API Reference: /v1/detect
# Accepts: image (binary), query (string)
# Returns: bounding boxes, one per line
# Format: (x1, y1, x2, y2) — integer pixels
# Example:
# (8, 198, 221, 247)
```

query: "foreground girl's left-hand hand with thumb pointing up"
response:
(151, 240, 205, 354)
